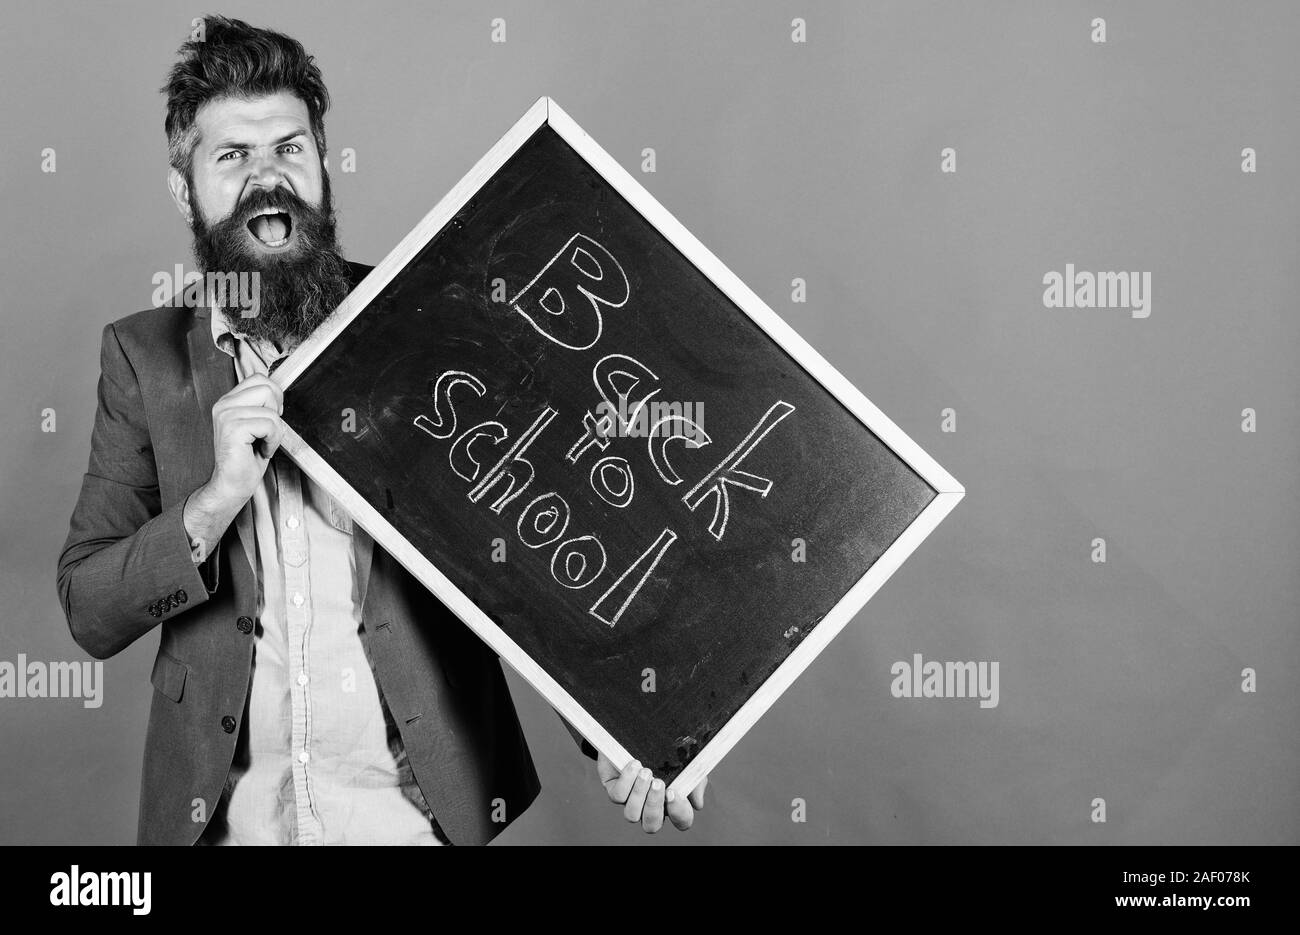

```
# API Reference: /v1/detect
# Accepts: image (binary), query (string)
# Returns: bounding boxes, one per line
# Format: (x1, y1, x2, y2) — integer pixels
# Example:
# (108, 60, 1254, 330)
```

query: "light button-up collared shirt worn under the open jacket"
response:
(199, 308, 449, 844)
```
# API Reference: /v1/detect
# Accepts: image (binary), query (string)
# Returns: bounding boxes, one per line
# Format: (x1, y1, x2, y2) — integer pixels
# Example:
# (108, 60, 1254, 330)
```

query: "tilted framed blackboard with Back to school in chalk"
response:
(278, 98, 963, 791)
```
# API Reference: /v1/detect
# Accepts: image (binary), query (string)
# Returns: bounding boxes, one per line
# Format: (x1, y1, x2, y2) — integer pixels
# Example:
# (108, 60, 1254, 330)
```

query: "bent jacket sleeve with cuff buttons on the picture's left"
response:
(57, 324, 218, 659)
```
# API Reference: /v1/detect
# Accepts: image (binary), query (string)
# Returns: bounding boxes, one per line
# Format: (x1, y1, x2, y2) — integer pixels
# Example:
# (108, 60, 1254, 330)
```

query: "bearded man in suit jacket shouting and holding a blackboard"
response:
(57, 17, 705, 844)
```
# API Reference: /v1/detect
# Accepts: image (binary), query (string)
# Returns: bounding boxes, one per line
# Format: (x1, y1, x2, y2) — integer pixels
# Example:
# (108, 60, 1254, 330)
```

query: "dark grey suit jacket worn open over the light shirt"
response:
(57, 264, 595, 844)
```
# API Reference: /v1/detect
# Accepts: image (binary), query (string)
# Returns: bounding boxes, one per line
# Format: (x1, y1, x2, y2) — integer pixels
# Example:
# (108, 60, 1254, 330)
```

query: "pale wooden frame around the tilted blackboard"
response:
(274, 98, 966, 795)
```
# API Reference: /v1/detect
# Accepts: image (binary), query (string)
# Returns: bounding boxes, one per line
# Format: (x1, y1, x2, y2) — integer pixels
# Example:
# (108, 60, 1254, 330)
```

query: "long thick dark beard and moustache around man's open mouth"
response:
(190, 176, 352, 349)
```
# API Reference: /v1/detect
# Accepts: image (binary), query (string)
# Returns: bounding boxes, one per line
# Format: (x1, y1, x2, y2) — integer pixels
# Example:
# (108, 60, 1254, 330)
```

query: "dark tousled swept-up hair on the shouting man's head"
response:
(160, 16, 329, 183)
